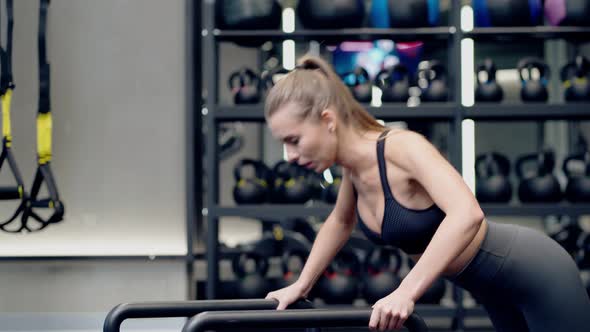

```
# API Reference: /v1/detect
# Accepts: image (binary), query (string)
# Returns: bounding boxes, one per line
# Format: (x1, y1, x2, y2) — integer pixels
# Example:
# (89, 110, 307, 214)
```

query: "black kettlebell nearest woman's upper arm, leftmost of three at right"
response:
(475, 152, 512, 203)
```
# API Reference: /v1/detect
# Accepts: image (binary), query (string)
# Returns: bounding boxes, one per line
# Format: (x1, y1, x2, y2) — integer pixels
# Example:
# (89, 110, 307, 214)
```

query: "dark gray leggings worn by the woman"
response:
(449, 222, 590, 332)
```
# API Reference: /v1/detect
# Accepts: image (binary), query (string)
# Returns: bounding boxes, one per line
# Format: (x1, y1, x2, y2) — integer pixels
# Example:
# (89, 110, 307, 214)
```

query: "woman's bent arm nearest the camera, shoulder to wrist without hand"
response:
(386, 131, 484, 302)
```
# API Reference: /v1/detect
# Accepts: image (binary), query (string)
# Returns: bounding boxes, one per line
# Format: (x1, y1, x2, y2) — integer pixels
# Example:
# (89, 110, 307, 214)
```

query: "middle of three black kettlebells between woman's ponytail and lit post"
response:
(375, 63, 410, 103)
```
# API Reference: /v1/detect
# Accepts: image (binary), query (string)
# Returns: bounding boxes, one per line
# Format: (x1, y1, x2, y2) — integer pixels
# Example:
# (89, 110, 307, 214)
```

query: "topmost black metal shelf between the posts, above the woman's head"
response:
(213, 27, 456, 42)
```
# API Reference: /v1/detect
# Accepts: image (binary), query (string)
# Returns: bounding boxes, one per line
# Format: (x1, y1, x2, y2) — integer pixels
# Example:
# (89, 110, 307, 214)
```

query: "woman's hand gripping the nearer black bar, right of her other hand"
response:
(369, 289, 414, 331)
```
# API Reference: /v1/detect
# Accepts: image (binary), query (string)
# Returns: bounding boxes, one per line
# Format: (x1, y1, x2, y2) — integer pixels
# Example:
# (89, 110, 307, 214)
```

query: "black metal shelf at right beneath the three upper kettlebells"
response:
(463, 103, 590, 121)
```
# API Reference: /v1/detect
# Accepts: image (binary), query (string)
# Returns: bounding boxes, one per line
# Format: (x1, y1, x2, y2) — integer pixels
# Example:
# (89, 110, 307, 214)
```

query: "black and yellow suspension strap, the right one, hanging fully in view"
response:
(22, 0, 64, 231)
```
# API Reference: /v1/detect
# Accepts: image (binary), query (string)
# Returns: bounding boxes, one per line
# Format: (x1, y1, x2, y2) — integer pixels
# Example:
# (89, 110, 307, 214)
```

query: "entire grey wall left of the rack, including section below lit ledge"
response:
(0, 0, 188, 322)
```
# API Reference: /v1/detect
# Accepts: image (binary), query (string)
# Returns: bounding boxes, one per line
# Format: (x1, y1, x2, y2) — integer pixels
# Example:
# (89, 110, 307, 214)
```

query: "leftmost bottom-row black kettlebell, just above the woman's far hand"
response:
(232, 251, 269, 299)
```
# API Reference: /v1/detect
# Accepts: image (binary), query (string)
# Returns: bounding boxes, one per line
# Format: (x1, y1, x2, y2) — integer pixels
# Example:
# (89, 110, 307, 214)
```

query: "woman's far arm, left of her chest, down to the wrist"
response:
(295, 170, 356, 296)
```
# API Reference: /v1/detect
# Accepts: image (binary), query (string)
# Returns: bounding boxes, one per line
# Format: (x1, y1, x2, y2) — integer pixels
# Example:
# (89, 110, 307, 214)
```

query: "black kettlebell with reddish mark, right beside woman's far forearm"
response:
(318, 246, 360, 304)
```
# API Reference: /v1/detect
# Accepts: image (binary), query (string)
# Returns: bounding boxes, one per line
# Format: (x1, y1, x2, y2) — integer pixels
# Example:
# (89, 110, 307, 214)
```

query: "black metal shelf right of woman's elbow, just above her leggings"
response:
(481, 203, 590, 217)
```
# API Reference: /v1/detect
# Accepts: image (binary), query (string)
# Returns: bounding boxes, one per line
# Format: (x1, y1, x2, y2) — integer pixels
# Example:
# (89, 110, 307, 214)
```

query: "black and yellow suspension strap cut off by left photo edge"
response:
(0, 0, 27, 233)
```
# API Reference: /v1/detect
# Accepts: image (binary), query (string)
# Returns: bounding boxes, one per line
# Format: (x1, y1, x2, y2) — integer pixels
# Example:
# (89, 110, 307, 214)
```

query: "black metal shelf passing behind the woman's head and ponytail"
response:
(212, 103, 457, 122)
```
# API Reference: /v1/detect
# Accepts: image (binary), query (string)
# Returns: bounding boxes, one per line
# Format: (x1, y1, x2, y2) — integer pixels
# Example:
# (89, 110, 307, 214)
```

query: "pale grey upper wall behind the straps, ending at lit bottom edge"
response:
(0, 0, 187, 256)
